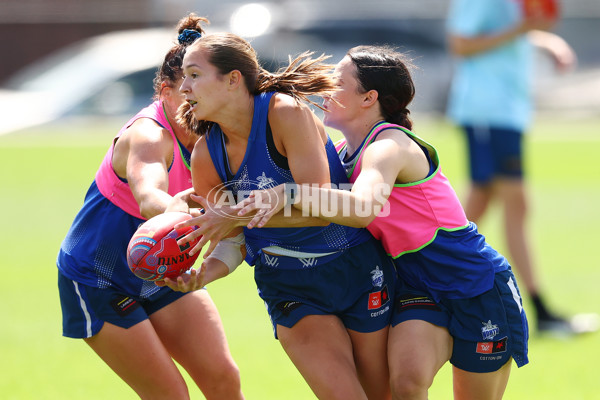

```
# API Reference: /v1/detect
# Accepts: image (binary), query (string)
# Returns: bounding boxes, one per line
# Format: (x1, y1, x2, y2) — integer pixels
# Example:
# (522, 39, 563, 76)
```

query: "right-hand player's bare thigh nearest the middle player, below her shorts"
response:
(388, 319, 453, 387)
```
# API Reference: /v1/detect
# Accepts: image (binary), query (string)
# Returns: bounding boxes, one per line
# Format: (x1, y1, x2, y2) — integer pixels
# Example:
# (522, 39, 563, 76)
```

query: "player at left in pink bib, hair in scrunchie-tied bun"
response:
(57, 14, 243, 400)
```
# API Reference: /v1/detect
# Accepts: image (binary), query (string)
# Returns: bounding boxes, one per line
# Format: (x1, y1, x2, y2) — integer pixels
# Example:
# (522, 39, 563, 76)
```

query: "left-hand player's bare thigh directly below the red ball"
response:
(150, 289, 233, 374)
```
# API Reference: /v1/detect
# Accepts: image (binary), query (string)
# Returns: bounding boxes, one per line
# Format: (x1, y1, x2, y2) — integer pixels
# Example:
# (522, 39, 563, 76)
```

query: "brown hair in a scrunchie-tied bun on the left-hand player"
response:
(154, 13, 210, 99)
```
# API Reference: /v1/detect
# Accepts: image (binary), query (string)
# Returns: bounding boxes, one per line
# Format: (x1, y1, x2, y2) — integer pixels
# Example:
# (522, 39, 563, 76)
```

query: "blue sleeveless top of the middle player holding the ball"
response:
(206, 92, 372, 265)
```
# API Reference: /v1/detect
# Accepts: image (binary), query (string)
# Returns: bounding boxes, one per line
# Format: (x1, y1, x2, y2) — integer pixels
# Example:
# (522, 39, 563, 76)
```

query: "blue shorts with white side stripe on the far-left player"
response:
(58, 272, 186, 339)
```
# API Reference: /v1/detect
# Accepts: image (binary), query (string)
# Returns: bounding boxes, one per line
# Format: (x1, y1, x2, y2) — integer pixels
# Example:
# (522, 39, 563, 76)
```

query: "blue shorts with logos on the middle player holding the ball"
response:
(254, 239, 396, 338)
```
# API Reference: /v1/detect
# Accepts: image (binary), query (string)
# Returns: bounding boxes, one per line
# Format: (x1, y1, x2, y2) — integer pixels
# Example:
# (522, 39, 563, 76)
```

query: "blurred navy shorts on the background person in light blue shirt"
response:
(463, 126, 523, 185)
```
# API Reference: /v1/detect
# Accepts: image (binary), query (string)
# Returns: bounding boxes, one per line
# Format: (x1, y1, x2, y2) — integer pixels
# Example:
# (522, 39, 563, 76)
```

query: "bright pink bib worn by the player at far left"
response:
(95, 101, 192, 219)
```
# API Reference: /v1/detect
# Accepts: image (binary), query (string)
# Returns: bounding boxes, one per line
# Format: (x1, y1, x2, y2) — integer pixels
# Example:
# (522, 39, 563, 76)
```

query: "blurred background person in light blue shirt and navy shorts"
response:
(447, 0, 576, 333)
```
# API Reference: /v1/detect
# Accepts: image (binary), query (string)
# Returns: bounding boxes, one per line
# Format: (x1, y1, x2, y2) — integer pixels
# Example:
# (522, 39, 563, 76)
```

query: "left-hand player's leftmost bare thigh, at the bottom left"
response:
(84, 319, 187, 397)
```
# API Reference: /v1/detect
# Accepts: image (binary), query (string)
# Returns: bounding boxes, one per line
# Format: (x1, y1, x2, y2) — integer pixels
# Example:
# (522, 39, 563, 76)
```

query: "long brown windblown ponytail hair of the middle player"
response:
(178, 33, 335, 134)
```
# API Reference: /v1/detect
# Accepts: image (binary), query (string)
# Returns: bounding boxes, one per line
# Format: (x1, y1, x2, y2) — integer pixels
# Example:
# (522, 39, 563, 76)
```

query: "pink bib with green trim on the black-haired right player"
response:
(336, 122, 469, 258)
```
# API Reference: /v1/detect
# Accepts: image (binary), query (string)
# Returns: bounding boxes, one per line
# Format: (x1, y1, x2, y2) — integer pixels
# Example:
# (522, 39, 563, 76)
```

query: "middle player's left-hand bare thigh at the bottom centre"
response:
(277, 315, 366, 399)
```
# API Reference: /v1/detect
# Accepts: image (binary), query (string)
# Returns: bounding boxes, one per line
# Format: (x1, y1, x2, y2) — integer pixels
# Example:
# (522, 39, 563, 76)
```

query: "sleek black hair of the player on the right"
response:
(346, 46, 415, 129)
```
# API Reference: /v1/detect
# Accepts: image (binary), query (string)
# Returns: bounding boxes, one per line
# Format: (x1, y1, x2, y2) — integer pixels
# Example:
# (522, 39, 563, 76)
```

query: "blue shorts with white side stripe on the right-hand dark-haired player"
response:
(392, 269, 529, 372)
